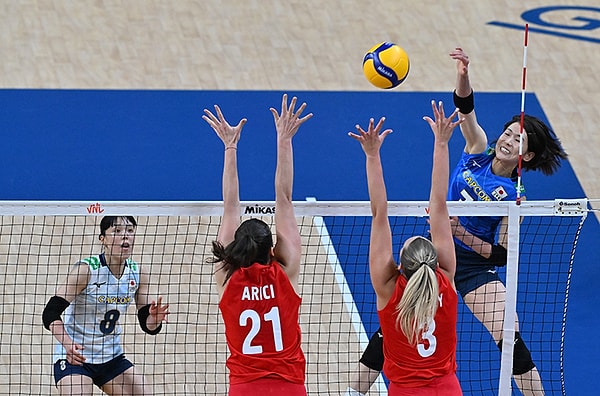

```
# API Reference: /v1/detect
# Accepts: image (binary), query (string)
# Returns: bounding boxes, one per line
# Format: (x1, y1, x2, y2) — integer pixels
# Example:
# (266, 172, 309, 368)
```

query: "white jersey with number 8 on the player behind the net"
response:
(54, 254, 140, 364)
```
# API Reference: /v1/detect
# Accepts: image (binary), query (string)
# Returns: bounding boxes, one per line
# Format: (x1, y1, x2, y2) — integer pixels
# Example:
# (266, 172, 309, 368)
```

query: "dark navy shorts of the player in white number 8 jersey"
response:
(54, 355, 133, 387)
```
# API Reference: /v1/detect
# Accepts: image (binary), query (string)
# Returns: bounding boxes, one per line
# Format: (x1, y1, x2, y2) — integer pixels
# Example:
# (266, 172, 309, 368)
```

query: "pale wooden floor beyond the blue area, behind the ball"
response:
(0, 0, 600, 394)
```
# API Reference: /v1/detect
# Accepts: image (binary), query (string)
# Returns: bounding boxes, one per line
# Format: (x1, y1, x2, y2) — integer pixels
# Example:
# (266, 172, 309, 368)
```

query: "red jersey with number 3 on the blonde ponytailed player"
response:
(378, 269, 458, 387)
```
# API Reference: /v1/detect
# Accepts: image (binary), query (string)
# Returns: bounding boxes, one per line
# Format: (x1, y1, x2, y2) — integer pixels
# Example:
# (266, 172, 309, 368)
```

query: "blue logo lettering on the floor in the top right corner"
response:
(488, 6, 600, 44)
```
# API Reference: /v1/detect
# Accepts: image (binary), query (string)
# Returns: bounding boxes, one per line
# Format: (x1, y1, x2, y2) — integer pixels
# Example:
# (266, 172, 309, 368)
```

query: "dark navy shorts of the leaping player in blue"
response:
(454, 245, 501, 298)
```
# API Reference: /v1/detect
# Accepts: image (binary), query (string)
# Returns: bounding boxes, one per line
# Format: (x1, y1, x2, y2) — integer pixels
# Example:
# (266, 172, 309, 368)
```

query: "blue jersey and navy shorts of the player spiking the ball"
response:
(448, 147, 524, 296)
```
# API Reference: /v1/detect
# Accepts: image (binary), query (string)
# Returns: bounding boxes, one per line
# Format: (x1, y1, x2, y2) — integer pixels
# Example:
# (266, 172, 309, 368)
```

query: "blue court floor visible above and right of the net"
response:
(0, 89, 600, 395)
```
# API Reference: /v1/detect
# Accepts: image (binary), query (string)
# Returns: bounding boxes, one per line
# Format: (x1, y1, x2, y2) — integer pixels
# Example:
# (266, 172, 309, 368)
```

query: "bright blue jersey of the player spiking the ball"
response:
(448, 147, 523, 250)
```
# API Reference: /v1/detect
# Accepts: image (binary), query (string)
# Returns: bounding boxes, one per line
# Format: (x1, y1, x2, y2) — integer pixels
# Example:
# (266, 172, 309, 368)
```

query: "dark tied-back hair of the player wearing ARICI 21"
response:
(208, 219, 273, 284)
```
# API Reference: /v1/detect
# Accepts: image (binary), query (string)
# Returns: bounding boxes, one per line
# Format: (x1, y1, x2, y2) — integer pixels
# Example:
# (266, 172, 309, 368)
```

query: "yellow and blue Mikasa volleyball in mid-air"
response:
(363, 41, 410, 89)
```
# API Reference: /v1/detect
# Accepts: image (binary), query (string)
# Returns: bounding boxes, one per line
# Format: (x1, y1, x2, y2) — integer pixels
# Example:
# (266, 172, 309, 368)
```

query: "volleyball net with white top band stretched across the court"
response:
(0, 199, 588, 395)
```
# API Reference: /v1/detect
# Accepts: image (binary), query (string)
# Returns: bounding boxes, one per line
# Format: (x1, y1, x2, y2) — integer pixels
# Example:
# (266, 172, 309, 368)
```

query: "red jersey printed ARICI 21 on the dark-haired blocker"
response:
(219, 261, 306, 384)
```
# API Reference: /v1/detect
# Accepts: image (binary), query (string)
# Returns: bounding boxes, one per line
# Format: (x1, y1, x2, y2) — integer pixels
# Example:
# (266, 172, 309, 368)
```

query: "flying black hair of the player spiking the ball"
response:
(502, 114, 567, 175)
